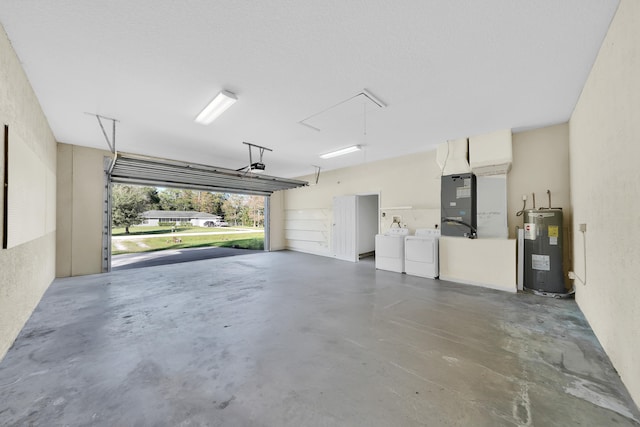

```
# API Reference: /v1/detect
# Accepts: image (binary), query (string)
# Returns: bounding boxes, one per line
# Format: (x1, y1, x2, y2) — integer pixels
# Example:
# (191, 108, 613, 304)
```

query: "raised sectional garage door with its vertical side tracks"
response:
(103, 153, 308, 272)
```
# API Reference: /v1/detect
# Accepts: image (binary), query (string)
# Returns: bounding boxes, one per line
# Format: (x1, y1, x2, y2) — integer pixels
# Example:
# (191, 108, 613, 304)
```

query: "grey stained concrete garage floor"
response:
(0, 252, 640, 426)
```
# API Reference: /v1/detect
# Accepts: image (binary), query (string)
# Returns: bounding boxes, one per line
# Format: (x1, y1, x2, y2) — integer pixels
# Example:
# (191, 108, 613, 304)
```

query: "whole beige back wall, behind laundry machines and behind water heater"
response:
(272, 123, 571, 260)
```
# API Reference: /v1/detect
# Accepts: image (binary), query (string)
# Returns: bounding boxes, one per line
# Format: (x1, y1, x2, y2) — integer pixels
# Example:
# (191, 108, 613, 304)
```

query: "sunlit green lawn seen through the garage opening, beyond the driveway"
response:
(111, 232, 264, 255)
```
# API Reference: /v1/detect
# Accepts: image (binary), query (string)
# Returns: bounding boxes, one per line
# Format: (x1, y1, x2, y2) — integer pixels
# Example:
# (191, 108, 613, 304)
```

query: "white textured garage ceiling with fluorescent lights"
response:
(0, 0, 618, 177)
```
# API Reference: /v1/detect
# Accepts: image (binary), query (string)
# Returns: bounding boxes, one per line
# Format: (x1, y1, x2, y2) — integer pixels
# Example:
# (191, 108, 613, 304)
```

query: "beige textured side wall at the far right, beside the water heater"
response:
(570, 0, 640, 403)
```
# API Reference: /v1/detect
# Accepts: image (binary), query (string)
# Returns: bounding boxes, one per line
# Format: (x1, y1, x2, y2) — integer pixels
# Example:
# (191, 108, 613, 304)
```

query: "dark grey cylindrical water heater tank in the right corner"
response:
(524, 209, 567, 294)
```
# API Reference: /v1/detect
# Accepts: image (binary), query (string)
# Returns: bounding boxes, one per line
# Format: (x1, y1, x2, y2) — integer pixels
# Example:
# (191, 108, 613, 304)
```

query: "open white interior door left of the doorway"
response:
(332, 196, 358, 262)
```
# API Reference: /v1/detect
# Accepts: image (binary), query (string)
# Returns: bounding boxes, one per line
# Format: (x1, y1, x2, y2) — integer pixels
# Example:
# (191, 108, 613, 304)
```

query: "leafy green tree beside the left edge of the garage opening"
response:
(111, 184, 149, 234)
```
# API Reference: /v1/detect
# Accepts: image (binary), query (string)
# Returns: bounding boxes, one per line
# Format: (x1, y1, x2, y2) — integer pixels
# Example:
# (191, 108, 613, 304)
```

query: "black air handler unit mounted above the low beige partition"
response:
(440, 173, 477, 241)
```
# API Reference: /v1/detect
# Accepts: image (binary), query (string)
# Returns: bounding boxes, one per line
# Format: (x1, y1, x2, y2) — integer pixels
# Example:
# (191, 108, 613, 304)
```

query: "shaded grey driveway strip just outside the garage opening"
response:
(111, 244, 264, 270)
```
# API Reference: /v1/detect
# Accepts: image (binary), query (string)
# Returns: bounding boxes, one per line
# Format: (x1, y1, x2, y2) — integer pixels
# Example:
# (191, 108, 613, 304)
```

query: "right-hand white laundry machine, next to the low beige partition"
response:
(404, 228, 440, 279)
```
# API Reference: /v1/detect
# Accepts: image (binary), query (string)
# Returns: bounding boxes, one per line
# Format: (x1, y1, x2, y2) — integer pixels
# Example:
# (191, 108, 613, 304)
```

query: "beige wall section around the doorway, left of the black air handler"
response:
(282, 150, 440, 256)
